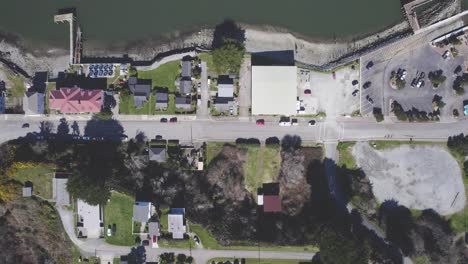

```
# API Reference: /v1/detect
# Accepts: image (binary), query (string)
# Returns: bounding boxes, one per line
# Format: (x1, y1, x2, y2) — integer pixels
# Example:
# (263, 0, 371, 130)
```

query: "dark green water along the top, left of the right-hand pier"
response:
(0, 0, 402, 47)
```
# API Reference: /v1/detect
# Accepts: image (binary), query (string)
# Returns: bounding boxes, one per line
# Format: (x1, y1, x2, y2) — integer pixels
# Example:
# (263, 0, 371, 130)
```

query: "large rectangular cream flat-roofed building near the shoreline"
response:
(252, 66, 297, 116)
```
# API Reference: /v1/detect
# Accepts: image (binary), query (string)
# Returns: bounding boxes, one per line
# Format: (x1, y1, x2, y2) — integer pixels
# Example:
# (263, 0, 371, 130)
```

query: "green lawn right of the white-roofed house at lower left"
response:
(104, 192, 136, 246)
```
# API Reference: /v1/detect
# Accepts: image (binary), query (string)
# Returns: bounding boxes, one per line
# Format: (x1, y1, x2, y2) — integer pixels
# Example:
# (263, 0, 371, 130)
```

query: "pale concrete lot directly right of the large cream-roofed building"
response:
(297, 67, 359, 118)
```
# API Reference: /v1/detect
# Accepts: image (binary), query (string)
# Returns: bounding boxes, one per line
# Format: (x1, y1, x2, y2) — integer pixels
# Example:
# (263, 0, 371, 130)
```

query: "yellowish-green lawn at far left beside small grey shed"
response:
(12, 163, 55, 199)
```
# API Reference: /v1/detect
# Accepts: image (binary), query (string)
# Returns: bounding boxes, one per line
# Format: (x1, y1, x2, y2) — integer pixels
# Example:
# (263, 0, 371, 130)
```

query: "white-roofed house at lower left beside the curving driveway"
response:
(76, 199, 104, 238)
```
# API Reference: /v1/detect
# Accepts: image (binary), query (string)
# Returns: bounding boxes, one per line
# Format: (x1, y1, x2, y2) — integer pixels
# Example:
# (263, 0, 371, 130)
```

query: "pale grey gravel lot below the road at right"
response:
(352, 142, 466, 215)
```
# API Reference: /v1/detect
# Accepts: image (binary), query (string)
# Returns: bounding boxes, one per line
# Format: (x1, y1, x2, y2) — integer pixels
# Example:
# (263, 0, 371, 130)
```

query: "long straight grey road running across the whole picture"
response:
(0, 117, 468, 143)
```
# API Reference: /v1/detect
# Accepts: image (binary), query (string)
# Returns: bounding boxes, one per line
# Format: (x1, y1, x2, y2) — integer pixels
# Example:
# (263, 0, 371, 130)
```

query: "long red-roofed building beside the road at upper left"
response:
(49, 88, 103, 114)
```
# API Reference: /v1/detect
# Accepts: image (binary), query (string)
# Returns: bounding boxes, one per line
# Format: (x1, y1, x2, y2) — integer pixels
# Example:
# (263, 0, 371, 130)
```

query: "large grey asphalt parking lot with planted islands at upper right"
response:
(360, 43, 468, 119)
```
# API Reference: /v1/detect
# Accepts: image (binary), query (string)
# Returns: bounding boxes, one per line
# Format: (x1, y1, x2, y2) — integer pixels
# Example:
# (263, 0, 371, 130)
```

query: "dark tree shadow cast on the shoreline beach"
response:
(211, 19, 245, 49)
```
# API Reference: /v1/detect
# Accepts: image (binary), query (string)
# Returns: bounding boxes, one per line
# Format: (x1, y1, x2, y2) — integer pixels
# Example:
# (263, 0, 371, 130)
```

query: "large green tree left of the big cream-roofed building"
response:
(212, 39, 245, 74)
